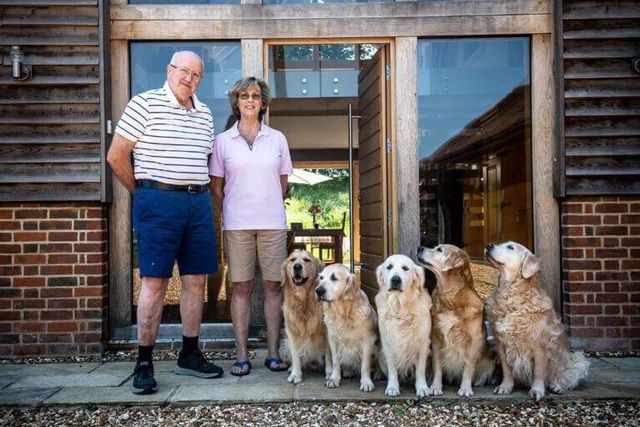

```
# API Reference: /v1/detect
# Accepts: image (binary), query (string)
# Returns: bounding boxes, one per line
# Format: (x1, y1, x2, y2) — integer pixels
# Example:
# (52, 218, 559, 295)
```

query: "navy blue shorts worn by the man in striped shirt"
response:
(133, 188, 218, 278)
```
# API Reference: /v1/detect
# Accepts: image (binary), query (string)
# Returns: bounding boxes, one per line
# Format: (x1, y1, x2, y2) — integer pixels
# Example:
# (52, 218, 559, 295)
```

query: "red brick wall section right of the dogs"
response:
(562, 197, 640, 350)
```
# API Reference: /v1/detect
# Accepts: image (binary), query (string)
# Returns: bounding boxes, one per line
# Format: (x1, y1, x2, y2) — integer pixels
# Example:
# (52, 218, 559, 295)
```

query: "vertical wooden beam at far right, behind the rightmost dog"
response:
(531, 34, 562, 312)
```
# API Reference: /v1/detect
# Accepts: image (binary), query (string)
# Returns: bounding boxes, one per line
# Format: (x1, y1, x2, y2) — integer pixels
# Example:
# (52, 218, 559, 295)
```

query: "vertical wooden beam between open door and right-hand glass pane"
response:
(392, 37, 420, 259)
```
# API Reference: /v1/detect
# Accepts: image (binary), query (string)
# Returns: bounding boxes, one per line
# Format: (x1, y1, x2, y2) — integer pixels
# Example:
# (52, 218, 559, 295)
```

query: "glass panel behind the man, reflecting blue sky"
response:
(130, 42, 242, 323)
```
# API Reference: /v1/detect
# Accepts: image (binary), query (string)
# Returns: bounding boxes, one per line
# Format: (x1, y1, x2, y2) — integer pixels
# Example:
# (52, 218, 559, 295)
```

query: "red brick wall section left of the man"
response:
(0, 202, 107, 357)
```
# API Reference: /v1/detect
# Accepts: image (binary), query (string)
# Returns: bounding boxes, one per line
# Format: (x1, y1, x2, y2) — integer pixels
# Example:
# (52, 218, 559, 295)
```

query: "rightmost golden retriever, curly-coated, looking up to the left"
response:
(485, 242, 589, 401)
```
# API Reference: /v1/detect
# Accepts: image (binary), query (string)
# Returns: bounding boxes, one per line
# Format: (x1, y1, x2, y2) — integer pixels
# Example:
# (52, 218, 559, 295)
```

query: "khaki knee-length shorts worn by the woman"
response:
(224, 230, 287, 282)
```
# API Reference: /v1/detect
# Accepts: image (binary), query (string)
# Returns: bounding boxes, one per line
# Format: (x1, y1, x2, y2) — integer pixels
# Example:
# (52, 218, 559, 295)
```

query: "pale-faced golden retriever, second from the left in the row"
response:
(316, 264, 378, 391)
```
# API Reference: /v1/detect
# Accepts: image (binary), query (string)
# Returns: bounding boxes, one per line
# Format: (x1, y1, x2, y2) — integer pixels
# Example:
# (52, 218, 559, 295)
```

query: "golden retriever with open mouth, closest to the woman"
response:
(281, 249, 331, 384)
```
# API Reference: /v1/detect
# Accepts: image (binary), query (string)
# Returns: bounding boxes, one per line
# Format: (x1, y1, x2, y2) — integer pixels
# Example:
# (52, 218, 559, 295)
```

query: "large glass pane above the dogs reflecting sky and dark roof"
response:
(418, 37, 533, 260)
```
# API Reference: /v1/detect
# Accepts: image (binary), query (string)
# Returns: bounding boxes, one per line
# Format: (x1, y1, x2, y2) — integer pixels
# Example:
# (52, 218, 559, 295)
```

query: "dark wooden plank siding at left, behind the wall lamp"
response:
(0, 0, 104, 201)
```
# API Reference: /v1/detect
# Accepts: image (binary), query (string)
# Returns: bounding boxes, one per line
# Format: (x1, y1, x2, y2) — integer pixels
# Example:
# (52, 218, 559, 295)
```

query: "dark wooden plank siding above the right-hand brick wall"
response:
(557, 0, 640, 196)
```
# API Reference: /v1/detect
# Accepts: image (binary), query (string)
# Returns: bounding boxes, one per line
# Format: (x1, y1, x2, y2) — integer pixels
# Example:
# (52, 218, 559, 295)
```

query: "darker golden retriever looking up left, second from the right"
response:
(418, 245, 496, 397)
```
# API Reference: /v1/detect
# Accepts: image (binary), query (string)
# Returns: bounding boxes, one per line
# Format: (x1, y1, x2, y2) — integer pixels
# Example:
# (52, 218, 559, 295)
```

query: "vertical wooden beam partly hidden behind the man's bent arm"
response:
(109, 40, 133, 336)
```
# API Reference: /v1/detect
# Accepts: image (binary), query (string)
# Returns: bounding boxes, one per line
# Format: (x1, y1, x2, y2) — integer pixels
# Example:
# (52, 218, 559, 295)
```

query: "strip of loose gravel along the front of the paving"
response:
(0, 401, 640, 427)
